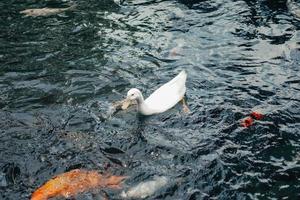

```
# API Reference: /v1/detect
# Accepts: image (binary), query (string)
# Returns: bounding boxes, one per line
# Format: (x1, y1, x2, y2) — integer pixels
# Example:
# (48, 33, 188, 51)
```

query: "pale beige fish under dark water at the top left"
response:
(20, 5, 76, 17)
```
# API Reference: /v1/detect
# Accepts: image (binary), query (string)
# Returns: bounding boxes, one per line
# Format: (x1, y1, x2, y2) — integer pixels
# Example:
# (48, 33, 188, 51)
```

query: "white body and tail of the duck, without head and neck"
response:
(145, 71, 187, 112)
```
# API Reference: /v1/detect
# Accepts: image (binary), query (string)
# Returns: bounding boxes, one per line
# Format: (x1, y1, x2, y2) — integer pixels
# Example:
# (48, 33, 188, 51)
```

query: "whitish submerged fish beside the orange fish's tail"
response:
(121, 176, 168, 198)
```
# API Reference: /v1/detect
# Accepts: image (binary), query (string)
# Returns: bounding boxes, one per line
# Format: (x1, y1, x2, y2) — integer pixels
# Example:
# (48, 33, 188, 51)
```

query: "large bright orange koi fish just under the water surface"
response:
(31, 169, 126, 200)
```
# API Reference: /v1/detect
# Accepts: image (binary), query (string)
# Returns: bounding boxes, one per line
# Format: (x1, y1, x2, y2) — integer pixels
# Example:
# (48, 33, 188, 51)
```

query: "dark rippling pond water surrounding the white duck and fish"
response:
(0, 0, 300, 200)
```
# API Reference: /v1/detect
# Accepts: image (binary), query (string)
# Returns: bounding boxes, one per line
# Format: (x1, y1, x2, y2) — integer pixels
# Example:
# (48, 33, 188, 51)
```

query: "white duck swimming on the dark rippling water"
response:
(126, 70, 187, 115)
